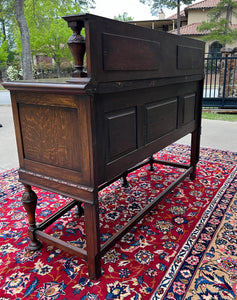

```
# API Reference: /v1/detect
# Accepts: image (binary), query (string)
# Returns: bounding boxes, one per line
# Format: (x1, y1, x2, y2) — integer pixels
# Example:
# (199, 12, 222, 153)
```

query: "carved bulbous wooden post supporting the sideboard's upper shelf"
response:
(67, 24, 87, 82)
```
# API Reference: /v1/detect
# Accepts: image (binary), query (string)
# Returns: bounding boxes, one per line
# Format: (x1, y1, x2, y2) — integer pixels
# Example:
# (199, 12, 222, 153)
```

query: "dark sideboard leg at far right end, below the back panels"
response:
(190, 128, 200, 180)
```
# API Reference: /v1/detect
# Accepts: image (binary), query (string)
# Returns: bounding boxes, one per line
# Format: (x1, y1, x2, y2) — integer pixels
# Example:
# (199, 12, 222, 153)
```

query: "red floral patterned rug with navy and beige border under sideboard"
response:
(0, 144, 237, 300)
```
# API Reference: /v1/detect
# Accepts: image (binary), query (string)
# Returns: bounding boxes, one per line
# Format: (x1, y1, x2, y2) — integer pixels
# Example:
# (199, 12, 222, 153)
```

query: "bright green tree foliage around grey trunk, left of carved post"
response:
(4, 0, 95, 77)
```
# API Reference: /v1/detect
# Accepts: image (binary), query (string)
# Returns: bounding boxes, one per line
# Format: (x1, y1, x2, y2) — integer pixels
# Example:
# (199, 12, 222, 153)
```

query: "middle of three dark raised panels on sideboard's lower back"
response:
(145, 98, 178, 144)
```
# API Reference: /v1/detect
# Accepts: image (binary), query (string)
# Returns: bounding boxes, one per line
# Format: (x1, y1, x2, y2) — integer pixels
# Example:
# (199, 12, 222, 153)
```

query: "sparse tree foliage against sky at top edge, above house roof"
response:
(140, 0, 193, 15)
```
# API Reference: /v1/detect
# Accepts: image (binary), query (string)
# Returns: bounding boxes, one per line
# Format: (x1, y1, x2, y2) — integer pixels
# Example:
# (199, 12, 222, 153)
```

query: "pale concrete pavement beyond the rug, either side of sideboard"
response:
(0, 104, 237, 172)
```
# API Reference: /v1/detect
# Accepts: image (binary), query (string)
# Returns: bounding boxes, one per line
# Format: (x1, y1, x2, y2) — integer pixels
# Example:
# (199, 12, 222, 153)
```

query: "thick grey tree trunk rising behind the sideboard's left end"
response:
(15, 0, 33, 80)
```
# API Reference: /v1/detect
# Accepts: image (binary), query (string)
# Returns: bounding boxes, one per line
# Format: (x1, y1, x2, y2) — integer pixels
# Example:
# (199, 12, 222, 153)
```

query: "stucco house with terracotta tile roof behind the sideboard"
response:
(130, 0, 237, 52)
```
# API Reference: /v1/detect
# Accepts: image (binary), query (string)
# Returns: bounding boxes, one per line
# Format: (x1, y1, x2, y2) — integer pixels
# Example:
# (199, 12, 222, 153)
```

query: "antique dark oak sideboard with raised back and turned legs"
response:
(4, 14, 204, 279)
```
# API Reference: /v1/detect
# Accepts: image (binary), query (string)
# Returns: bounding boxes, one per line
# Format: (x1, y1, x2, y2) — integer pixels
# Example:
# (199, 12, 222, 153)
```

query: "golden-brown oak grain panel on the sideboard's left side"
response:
(19, 104, 82, 171)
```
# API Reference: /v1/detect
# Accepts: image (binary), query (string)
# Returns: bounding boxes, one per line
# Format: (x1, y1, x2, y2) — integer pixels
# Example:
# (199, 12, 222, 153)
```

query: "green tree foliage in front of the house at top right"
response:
(198, 0, 237, 44)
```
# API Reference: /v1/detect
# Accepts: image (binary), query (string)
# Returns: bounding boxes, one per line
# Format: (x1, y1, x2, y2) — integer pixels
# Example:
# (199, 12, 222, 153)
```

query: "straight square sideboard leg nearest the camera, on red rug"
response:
(84, 203, 101, 280)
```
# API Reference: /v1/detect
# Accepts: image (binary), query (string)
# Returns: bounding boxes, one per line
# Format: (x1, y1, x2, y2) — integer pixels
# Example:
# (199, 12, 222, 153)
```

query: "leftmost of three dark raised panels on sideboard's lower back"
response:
(105, 107, 137, 162)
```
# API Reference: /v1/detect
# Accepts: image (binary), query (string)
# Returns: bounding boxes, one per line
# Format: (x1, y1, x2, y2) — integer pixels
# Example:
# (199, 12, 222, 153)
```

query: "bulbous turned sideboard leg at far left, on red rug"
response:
(21, 185, 42, 250)
